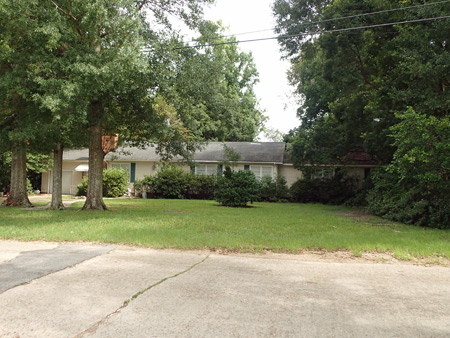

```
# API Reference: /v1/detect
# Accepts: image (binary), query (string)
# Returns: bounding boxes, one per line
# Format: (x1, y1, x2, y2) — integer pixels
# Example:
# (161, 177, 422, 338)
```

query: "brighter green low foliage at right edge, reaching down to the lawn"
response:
(367, 109, 450, 229)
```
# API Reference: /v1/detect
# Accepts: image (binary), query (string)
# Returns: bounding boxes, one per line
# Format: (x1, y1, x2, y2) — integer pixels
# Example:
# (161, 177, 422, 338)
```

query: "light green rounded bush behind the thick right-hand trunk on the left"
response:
(76, 168, 129, 197)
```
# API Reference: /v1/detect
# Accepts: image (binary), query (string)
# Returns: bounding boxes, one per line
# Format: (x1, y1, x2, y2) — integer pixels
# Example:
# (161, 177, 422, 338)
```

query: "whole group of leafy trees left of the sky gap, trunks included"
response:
(0, 0, 264, 209)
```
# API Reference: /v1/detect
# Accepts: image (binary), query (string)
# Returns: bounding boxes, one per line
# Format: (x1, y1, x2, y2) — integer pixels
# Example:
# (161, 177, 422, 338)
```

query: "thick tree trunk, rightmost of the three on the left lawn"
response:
(83, 123, 106, 210)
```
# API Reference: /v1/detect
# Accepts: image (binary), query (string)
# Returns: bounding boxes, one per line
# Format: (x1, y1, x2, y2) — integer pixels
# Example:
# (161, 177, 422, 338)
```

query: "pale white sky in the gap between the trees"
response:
(195, 0, 300, 141)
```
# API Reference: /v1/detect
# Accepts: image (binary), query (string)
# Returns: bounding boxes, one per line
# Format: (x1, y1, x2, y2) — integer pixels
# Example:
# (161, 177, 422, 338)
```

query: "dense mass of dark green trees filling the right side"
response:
(273, 0, 450, 227)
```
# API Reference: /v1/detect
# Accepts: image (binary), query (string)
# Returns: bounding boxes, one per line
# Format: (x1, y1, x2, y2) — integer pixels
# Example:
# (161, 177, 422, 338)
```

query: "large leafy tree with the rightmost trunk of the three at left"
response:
(0, 0, 213, 209)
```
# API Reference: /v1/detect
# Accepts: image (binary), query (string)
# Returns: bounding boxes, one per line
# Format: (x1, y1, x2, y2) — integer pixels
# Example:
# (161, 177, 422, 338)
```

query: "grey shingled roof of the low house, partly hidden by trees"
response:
(63, 142, 286, 163)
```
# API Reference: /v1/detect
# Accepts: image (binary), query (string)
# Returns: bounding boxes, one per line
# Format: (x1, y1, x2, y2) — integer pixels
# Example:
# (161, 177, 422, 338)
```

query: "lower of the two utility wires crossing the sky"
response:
(175, 15, 450, 49)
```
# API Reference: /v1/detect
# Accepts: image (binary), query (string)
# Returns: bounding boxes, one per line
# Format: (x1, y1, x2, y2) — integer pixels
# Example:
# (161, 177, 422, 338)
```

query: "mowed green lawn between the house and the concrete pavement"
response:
(0, 199, 450, 259)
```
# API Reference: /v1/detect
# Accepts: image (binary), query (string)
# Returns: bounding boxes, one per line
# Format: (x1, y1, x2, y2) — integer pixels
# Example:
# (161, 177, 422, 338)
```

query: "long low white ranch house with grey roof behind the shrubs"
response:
(41, 142, 376, 195)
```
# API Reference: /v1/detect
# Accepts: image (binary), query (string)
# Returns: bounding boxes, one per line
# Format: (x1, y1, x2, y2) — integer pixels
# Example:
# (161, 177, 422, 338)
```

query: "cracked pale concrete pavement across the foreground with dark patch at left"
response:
(0, 241, 450, 338)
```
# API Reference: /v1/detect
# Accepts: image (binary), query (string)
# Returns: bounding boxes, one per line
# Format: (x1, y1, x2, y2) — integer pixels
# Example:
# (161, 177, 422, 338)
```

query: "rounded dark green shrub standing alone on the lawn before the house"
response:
(214, 167, 260, 207)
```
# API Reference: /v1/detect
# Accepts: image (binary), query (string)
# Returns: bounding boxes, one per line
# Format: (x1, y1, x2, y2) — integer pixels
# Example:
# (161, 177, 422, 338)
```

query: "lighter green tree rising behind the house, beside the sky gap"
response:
(166, 21, 265, 141)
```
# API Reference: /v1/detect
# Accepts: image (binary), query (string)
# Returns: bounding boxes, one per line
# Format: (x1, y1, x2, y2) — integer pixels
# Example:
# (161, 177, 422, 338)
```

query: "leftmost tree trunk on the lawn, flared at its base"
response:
(4, 143, 32, 207)
